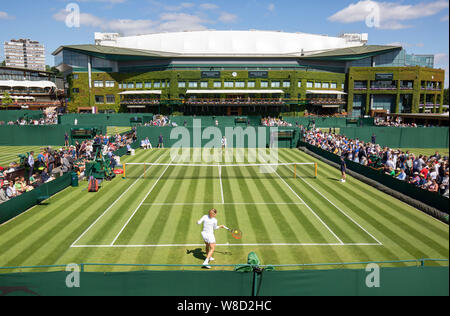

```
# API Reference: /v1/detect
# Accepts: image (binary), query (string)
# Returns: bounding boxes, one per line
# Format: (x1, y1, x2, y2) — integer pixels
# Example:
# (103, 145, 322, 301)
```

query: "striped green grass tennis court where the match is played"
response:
(0, 149, 449, 271)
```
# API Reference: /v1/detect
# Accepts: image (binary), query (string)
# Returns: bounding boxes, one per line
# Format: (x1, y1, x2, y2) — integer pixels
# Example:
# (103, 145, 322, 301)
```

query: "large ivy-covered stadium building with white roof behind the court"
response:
(53, 31, 445, 117)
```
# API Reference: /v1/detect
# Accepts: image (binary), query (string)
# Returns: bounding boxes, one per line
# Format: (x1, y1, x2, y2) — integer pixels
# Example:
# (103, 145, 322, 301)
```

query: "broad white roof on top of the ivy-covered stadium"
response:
(95, 30, 367, 57)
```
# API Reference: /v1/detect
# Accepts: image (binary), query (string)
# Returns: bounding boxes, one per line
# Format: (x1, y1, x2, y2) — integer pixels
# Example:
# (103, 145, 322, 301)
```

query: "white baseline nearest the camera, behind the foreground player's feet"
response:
(71, 243, 381, 248)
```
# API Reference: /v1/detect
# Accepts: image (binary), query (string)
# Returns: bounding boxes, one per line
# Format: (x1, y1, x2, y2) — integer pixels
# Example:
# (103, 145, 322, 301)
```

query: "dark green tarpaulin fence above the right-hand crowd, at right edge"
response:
(340, 127, 449, 148)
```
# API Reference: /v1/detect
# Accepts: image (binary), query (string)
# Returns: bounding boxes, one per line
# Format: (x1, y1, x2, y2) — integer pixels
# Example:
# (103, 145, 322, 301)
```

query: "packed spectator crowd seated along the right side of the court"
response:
(302, 129, 449, 198)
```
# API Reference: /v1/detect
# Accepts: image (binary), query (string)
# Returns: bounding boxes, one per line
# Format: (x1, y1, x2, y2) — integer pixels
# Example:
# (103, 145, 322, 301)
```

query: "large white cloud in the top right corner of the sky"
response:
(328, 0, 449, 30)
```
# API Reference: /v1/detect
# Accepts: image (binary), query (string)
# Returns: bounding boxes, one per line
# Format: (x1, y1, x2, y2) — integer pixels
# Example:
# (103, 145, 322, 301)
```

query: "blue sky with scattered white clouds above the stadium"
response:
(0, 0, 449, 85)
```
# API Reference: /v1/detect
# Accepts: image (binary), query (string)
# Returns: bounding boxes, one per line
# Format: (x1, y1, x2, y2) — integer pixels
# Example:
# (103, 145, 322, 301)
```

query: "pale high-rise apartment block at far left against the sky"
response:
(4, 39, 45, 71)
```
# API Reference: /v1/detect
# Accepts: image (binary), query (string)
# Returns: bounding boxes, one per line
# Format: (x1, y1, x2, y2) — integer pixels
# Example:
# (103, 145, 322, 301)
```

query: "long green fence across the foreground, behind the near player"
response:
(0, 259, 449, 297)
